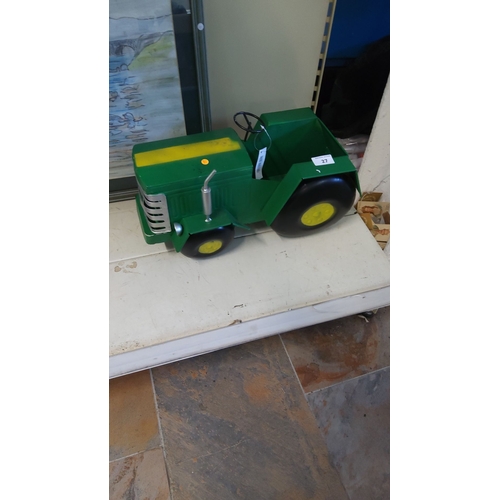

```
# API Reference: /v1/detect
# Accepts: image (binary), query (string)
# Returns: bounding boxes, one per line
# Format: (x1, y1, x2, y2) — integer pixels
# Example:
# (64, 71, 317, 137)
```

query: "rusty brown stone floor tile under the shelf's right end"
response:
(281, 307, 390, 393)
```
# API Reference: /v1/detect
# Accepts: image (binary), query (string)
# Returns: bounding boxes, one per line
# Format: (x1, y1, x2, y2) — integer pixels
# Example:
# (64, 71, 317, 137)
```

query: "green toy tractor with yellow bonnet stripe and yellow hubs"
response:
(132, 108, 361, 257)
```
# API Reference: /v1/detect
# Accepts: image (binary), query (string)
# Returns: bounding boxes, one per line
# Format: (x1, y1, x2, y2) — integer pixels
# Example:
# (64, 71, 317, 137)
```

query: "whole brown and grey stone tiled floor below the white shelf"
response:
(109, 308, 390, 500)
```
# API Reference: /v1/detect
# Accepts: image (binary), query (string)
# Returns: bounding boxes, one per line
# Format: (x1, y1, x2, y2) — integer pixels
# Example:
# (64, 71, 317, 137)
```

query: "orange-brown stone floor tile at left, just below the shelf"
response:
(109, 370, 160, 460)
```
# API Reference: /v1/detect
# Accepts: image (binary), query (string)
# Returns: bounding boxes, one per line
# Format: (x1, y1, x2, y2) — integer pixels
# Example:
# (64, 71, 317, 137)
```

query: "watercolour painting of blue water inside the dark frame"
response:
(109, 0, 186, 179)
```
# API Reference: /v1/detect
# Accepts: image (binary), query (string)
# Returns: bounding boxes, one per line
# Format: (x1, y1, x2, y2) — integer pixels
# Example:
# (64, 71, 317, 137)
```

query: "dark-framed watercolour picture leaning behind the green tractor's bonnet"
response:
(109, 0, 210, 201)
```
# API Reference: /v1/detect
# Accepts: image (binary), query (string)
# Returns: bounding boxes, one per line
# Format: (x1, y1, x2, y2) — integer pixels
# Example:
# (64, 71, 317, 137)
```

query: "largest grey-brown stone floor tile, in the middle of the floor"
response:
(152, 336, 348, 500)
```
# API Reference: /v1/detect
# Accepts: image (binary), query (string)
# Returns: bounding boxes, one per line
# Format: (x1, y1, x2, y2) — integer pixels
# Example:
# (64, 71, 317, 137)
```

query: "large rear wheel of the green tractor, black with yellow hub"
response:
(271, 174, 356, 236)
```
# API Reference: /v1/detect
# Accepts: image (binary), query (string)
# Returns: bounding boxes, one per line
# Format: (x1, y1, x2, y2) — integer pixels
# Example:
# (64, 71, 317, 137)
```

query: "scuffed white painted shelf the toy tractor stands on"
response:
(109, 201, 389, 377)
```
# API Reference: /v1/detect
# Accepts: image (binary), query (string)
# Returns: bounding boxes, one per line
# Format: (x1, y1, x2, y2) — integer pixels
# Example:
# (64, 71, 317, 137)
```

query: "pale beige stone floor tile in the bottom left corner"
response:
(109, 448, 170, 500)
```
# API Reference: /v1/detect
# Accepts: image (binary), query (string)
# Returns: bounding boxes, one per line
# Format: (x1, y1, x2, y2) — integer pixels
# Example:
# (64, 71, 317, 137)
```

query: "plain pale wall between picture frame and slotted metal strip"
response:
(203, 0, 329, 132)
